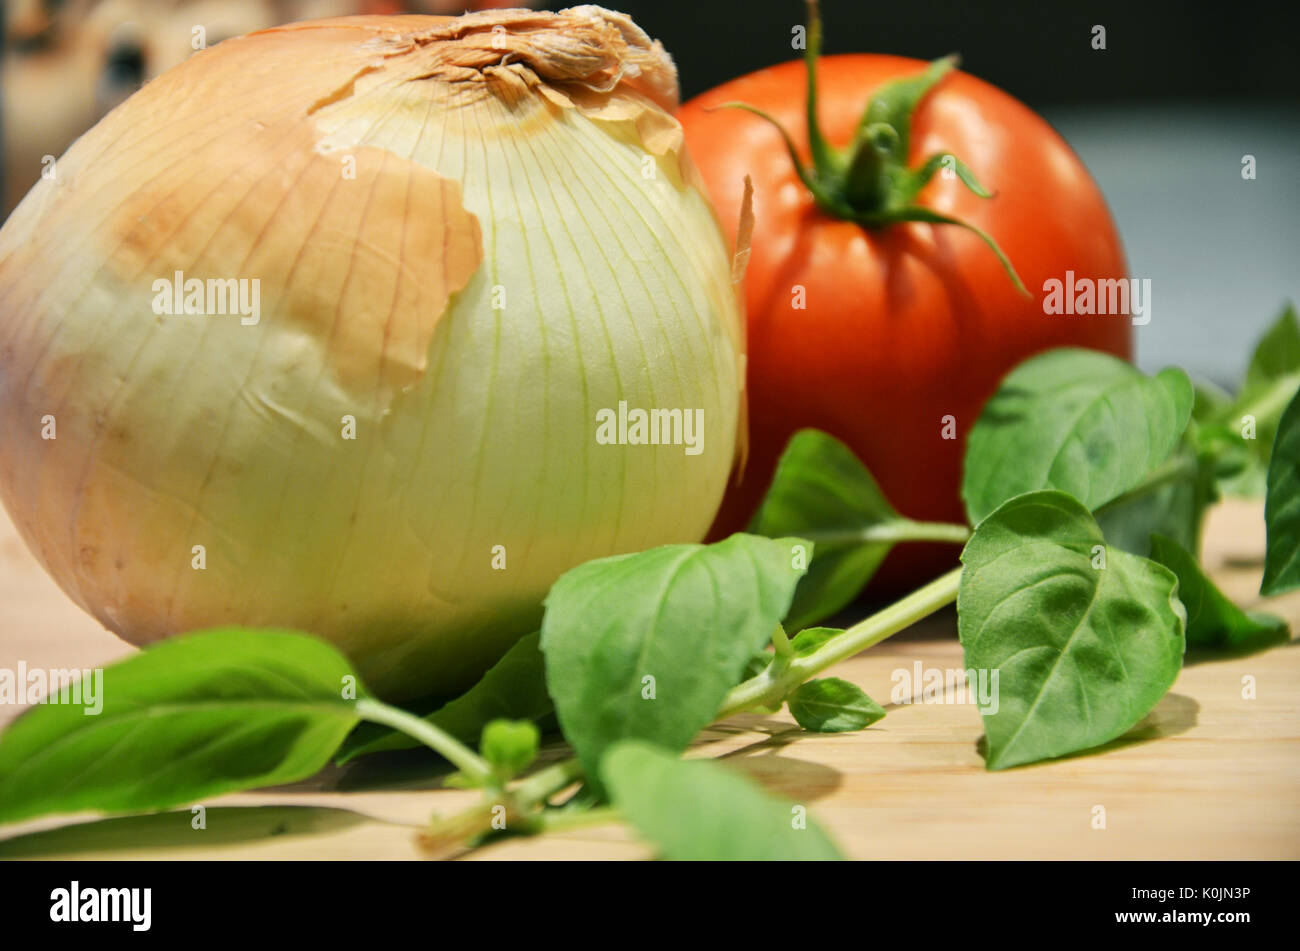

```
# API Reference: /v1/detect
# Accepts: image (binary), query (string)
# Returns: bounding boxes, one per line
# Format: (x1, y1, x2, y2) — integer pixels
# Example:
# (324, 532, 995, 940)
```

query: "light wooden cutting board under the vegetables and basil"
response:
(0, 501, 1300, 859)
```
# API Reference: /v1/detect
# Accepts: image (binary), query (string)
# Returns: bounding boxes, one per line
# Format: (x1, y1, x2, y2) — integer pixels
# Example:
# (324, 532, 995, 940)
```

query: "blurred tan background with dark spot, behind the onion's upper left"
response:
(0, 0, 533, 216)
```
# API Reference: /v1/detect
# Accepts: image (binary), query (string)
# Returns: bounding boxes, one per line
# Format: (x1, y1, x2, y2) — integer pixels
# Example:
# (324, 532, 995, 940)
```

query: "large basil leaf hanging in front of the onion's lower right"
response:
(542, 534, 811, 777)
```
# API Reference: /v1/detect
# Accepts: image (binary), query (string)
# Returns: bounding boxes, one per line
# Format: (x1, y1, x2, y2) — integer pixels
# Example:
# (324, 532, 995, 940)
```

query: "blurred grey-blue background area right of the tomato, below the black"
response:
(1047, 97, 1300, 390)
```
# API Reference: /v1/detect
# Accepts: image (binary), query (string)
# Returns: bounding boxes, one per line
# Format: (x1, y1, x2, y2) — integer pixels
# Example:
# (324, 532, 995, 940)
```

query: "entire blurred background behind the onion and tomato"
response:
(0, 0, 1300, 386)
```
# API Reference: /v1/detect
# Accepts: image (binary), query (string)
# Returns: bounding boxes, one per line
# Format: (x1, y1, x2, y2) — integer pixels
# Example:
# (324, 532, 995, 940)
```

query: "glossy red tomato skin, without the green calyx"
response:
(679, 55, 1132, 589)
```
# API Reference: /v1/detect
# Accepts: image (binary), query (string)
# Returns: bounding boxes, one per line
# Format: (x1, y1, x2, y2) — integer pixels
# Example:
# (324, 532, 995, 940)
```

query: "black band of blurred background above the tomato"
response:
(615, 0, 1300, 109)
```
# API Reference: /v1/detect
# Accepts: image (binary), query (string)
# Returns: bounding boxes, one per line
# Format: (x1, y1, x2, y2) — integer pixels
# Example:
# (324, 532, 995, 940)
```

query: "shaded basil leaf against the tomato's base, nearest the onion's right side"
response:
(749, 429, 911, 630)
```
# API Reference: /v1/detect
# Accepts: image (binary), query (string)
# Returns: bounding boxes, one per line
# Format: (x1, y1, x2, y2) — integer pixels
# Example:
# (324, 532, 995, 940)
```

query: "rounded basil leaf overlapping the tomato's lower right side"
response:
(962, 348, 1193, 525)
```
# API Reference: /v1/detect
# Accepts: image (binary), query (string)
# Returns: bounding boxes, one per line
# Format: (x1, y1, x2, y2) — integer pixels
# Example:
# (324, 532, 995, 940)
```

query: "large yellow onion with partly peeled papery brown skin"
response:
(0, 6, 744, 699)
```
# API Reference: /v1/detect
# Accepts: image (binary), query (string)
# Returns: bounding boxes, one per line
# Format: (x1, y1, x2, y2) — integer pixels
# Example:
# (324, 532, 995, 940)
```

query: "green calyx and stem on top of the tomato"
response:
(718, 0, 1028, 295)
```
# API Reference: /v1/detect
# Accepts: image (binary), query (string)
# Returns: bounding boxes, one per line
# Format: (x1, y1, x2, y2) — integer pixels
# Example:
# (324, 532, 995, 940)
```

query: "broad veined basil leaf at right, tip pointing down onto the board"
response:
(957, 490, 1184, 769)
